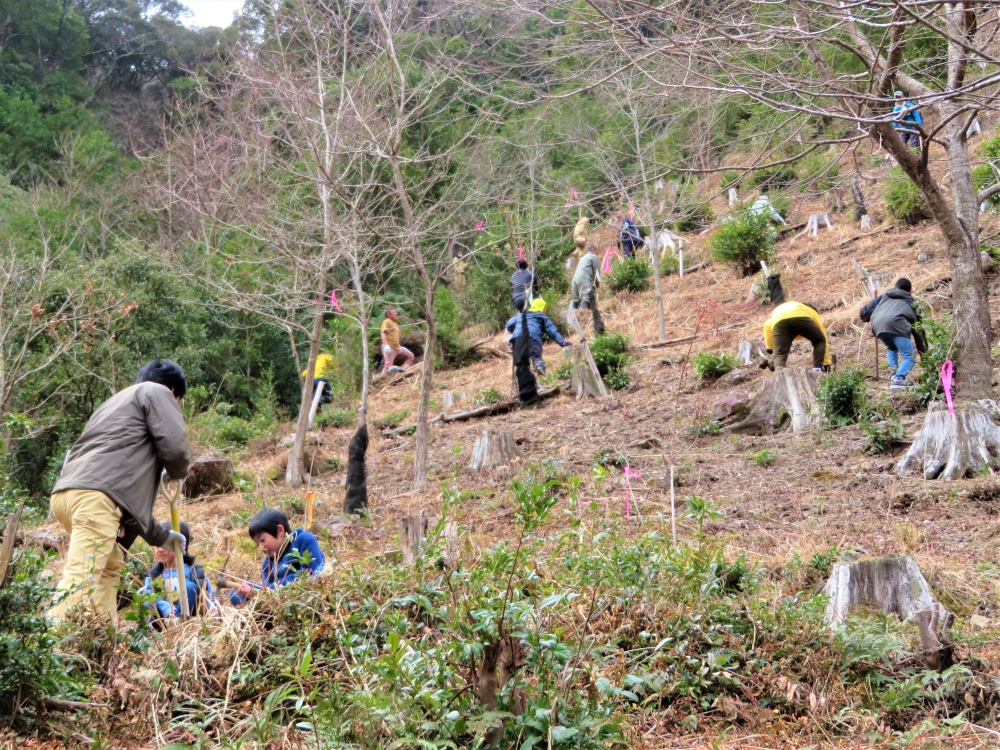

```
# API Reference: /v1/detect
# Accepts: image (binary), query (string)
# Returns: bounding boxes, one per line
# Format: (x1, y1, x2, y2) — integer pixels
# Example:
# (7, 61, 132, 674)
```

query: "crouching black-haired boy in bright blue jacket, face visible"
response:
(229, 508, 326, 606)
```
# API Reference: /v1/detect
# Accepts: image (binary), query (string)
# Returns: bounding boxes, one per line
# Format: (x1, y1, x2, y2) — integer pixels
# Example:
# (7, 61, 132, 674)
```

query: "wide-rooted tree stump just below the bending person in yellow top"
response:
(723, 367, 823, 435)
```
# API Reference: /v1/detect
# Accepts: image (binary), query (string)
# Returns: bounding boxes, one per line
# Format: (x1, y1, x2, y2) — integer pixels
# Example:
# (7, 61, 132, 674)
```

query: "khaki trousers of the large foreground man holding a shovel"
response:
(49, 490, 125, 621)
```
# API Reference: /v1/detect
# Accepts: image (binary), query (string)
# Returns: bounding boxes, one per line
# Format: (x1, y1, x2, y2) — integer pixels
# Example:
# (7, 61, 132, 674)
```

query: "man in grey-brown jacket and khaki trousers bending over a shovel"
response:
(49, 360, 189, 620)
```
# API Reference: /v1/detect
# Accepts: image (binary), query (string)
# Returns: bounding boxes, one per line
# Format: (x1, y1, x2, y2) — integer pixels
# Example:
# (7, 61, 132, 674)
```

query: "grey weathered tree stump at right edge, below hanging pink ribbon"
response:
(893, 399, 1000, 481)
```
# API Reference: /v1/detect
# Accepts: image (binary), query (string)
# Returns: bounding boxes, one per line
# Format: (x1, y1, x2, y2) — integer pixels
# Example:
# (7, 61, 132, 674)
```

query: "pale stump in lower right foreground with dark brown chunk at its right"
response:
(823, 556, 955, 670)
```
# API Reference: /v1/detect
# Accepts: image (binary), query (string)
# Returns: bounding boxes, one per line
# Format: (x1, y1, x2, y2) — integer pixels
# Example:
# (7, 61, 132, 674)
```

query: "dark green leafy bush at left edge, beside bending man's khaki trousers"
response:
(0, 547, 86, 722)
